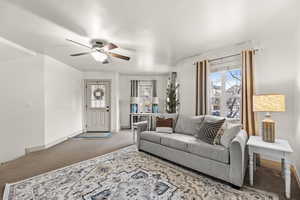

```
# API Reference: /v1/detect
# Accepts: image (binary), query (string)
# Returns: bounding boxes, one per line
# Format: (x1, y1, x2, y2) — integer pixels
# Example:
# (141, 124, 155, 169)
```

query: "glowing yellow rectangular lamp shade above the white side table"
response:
(253, 94, 285, 112)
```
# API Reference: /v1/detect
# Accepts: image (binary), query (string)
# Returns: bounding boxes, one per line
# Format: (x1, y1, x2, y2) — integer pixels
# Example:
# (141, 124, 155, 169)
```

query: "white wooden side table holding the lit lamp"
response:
(247, 136, 293, 199)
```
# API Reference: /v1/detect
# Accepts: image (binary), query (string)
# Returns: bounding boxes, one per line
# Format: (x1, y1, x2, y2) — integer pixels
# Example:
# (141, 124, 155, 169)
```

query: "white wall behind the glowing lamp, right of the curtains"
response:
(255, 32, 300, 166)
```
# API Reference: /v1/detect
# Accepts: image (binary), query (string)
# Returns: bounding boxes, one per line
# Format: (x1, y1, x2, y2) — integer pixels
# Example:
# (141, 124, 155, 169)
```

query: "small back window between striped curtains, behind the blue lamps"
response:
(138, 81, 153, 113)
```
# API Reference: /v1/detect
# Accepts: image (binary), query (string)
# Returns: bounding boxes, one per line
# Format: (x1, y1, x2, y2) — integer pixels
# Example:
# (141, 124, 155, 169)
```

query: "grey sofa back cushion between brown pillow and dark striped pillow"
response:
(175, 115, 204, 135)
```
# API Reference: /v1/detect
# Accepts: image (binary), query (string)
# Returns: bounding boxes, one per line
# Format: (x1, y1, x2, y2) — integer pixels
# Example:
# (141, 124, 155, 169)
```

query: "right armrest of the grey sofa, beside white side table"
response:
(229, 130, 248, 187)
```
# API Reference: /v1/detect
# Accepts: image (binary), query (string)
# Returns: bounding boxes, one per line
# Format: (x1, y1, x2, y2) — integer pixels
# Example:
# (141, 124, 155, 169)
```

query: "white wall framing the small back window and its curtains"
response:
(119, 74, 168, 128)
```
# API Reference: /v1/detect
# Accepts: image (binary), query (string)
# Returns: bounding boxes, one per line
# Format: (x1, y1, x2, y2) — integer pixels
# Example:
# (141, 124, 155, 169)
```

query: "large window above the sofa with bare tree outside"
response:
(208, 57, 242, 120)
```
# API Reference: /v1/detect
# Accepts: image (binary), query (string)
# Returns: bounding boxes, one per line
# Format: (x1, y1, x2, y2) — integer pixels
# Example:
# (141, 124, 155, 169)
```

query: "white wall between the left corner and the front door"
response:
(44, 56, 83, 146)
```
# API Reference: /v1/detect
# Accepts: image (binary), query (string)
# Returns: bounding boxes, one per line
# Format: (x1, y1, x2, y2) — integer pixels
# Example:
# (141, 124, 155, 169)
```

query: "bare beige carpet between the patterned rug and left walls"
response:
(0, 131, 133, 199)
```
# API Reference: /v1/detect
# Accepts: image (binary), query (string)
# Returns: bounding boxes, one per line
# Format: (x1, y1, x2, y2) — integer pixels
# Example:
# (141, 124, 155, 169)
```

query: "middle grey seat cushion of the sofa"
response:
(160, 133, 196, 152)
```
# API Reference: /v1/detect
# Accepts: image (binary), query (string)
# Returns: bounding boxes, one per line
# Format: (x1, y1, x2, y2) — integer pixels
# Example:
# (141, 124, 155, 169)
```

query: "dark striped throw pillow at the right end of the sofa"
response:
(197, 119, 225, 144)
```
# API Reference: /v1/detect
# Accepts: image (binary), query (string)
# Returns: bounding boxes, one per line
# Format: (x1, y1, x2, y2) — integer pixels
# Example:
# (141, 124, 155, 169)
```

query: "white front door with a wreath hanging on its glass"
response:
(85, 80, 110, 131)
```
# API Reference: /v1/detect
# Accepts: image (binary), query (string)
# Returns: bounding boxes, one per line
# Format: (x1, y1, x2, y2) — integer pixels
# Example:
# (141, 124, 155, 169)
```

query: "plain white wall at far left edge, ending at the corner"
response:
(0, 55, 44, 163)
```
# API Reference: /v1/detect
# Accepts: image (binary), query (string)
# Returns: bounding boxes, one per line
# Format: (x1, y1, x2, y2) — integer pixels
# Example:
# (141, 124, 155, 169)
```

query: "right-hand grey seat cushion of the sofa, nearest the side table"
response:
(188, 140, 229, 163)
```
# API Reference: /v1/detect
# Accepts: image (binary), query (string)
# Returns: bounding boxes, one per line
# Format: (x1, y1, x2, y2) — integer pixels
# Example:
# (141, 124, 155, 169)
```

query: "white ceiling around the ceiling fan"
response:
(0, 0, 297, 73)
